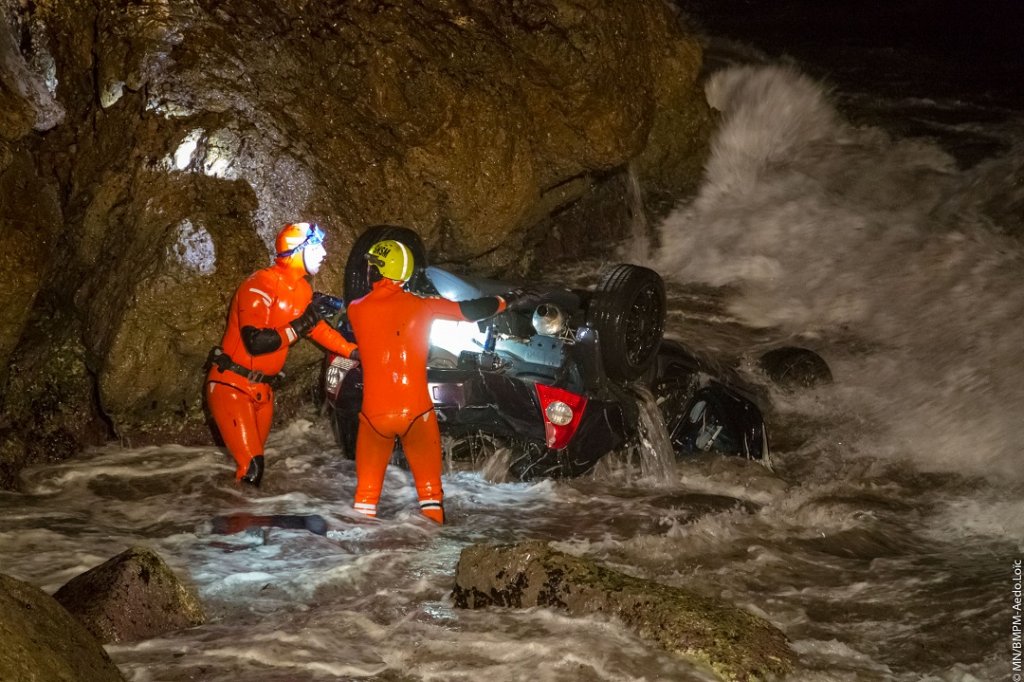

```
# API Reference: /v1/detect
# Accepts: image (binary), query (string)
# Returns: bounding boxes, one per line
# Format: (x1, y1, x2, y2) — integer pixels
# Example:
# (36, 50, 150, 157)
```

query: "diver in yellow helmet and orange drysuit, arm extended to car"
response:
(347, 241, 524, 523)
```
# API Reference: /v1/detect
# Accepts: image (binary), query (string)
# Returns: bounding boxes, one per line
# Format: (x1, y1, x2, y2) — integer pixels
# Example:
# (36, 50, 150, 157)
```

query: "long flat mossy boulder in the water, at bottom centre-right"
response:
(452, 541, 796, 680)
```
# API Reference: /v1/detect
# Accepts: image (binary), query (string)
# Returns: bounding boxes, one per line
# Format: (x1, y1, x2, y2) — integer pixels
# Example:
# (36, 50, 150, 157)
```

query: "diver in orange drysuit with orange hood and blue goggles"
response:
(206, 222, 355, 486)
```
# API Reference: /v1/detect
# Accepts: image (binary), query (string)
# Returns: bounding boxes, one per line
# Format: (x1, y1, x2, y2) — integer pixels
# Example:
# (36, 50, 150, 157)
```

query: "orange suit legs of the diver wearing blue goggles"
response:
(207, 381, 273, 480)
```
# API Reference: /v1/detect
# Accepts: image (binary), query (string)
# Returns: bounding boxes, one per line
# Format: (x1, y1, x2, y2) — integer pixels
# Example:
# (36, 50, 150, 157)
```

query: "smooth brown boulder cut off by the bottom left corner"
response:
(0, 573, 125, 682)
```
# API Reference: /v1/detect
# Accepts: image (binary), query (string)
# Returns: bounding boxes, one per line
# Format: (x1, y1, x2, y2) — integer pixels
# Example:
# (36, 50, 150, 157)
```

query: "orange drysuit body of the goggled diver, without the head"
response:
(206, 259, 355, 483)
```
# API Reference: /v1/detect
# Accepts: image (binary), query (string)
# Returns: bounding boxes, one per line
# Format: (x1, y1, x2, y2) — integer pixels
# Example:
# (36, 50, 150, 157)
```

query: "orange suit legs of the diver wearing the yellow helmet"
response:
(354, 408, 444, 523)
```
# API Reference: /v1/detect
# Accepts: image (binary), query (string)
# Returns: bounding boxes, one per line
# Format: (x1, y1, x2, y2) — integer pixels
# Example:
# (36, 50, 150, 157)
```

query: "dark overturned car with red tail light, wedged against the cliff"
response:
(324, 225, 770, 479)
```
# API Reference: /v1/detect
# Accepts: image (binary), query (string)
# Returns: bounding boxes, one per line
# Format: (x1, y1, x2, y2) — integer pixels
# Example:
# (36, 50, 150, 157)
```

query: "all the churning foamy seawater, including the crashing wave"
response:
(0, 61, 1024, 682)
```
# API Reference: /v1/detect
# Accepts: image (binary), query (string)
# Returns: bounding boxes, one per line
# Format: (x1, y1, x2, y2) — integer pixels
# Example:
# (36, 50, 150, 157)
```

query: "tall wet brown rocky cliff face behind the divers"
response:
(0, 0, 712, 486)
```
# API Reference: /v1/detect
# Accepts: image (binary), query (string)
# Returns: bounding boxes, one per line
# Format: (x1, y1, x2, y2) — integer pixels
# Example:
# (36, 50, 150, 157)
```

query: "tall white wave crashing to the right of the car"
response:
(654, 62, 1024, 480)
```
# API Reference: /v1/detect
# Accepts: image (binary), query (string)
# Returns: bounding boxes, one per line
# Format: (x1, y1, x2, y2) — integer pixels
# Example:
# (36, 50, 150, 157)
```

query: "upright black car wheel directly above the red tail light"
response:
(587, 263, 666, 381)
